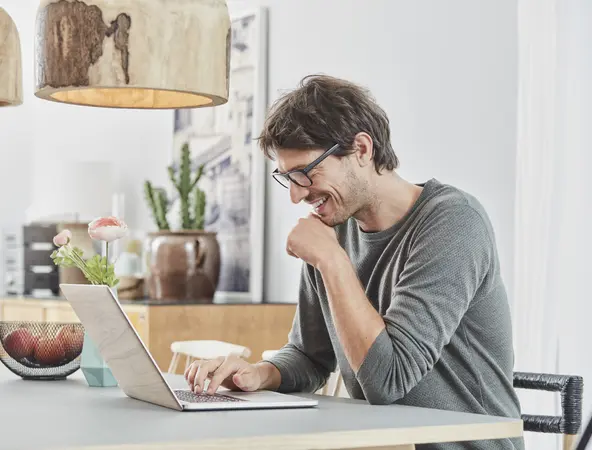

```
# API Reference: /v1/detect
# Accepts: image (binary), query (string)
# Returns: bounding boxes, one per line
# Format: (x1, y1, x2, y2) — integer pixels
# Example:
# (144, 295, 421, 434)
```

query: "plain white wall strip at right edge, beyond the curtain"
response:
(554, 0, 592, 425)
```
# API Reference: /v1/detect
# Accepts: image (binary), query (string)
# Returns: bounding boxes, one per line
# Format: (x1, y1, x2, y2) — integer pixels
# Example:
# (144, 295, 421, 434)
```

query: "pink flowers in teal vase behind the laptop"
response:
(51, 217, 128, 387)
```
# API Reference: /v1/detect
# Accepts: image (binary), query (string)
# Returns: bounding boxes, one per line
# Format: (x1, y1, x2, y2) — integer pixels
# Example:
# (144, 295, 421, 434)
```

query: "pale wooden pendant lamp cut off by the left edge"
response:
(0, 7, 23, 106)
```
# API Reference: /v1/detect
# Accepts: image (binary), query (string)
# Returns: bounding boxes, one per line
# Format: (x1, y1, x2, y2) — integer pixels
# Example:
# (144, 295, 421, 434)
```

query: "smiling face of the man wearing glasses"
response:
(277, 149, 368, 227)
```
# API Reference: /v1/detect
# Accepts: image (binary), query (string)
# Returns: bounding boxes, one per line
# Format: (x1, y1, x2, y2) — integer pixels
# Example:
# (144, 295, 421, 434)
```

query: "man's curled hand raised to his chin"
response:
(286, 214, 342, 269)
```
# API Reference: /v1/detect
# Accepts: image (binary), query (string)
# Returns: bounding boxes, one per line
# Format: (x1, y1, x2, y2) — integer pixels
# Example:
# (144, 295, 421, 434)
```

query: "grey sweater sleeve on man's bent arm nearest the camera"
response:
(356, 205, 493, 404)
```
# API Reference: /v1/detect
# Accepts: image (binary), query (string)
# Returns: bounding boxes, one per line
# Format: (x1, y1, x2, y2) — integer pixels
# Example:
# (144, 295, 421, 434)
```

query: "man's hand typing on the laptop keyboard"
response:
(185, 355, 262, 394)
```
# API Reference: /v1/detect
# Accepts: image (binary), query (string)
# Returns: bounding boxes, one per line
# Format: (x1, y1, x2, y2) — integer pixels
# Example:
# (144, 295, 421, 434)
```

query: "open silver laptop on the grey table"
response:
(60, 284, 318, 411)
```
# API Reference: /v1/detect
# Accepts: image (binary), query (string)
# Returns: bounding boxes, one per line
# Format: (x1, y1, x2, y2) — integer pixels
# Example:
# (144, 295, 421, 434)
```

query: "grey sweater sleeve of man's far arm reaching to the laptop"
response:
(266, 264, 336, 393)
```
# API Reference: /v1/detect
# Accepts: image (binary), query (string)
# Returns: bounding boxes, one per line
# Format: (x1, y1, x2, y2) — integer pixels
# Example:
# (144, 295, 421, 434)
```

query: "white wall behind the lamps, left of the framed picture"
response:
(0, 0, 173, 230)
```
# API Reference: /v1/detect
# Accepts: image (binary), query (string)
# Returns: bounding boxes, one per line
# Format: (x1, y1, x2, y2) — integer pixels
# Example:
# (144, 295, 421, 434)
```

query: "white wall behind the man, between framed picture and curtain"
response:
(229, 0, 517, 302)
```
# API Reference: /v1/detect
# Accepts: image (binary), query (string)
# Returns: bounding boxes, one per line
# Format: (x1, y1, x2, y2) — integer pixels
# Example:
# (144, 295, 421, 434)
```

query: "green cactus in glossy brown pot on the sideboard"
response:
(144, 144, 220, 303)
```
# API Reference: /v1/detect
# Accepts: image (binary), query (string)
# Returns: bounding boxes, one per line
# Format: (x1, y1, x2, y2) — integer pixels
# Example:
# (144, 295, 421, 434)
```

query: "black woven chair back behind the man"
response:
(514, 372, 584, 450)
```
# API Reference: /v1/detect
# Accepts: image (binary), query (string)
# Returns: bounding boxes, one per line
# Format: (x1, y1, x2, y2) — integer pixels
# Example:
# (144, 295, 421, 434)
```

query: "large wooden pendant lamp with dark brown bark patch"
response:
(35, 0, 231, 109)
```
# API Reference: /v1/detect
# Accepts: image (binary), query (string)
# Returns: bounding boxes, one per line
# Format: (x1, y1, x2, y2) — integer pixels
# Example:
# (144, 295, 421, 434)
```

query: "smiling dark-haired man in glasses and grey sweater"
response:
(186, 76, 523, 449)
